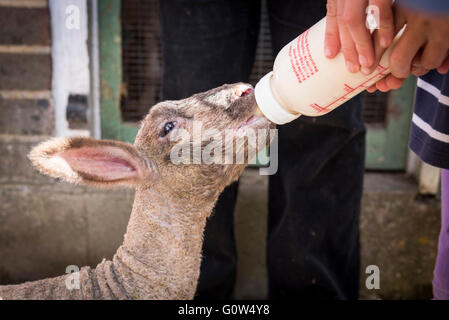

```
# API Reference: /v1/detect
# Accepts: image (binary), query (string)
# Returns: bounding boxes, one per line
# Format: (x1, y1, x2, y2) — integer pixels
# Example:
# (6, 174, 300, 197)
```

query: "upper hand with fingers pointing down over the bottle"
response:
(325, 0, 395, 74)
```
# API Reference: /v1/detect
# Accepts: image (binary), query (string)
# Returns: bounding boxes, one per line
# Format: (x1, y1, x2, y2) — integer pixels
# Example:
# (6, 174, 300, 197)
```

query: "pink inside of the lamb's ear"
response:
(58, 146, 138, 181)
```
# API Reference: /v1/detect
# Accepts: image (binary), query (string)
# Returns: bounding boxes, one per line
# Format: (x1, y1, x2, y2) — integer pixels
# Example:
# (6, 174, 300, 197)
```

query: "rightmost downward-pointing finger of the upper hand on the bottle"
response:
(370, 0, 394, 49)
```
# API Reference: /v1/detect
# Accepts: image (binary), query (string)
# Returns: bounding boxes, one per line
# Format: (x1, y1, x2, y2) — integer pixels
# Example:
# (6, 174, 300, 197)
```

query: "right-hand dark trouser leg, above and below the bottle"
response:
(267, 0, 365, 299)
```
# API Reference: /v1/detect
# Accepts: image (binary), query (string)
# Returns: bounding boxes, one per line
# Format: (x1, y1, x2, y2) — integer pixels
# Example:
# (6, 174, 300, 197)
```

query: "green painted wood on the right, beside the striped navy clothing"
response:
(365, 77, 416, 170)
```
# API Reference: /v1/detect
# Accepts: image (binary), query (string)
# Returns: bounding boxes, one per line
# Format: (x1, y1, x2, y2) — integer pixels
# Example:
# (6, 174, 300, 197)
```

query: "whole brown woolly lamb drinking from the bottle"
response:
(0, 83, 272, 300)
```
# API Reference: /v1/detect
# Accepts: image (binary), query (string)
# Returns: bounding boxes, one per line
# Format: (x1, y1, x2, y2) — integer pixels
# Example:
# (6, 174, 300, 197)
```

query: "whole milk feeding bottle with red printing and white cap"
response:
(255, 18, 403, 124)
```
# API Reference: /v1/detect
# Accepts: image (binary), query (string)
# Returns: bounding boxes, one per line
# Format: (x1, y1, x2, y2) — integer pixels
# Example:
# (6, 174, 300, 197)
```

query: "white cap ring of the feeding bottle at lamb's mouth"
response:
(255, 71, 301, 124)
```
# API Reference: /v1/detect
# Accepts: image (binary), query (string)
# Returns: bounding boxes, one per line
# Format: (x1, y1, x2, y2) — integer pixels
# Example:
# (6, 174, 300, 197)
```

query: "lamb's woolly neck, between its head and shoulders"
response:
(113, 188, 215, 299)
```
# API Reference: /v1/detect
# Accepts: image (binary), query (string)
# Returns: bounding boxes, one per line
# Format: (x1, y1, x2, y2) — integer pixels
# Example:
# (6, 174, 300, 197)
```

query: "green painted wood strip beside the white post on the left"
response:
(98, 0, 138, 142)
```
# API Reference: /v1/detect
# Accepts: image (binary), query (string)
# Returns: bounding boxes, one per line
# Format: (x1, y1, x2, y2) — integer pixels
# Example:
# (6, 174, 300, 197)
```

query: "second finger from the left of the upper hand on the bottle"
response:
(337, 0, 360, 73)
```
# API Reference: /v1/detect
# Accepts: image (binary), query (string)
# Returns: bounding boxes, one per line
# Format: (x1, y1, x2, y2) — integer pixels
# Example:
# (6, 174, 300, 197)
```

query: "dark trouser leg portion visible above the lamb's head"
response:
(159, 0, 260, 100)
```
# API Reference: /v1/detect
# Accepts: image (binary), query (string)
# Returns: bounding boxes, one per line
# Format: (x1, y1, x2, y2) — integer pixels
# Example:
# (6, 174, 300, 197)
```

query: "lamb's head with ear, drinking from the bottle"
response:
(30, 83, 272, 202)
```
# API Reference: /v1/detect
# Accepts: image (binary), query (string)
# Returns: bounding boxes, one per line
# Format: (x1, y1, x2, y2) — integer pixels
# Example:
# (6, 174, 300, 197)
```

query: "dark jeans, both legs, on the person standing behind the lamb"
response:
(160, 0, 365, 299)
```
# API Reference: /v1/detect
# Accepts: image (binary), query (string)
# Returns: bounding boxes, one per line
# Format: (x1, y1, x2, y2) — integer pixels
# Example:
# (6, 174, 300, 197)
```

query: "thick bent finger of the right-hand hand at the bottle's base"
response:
(390, 28, 424, 78)
